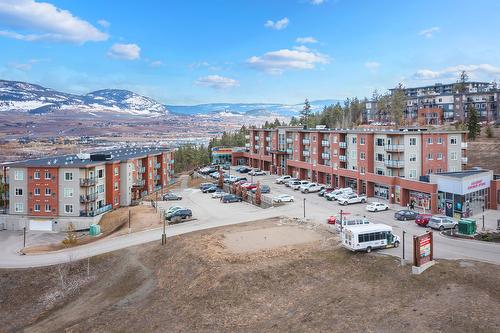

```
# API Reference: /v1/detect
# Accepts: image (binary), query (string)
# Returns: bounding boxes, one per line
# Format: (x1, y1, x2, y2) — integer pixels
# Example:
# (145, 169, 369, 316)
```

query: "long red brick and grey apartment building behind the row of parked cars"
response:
(233, 127, 496, 213)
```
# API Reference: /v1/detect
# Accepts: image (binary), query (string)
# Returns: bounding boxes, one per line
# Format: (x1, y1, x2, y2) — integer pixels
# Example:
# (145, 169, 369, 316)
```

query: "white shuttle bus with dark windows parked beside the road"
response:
(342, 224, 400, 252)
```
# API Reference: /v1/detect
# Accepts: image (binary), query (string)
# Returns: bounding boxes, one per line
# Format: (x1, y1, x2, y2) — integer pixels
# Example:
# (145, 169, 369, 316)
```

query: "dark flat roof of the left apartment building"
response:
(5, 147, 169, 168)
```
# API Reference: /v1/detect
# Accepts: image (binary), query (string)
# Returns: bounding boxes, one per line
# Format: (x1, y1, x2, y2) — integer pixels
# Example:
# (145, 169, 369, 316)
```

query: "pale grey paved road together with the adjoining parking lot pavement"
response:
(0, 167, 500, 268)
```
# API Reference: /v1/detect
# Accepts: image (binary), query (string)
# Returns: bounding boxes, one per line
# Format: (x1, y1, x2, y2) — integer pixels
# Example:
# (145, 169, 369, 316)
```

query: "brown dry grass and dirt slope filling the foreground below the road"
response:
(0, 218, 500, 332)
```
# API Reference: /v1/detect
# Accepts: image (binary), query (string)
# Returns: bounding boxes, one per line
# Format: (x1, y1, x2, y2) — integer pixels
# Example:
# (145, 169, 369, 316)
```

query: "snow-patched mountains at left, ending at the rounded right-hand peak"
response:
(0, 80, 168, 117)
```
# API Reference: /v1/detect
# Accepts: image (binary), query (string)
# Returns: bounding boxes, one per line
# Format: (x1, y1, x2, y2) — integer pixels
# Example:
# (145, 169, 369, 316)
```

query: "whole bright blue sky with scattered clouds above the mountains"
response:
(0, 0, 500, 105)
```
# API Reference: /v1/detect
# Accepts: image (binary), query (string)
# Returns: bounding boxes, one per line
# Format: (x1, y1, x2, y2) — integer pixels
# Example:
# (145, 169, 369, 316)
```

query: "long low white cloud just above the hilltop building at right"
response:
(413, 64, 500, 80)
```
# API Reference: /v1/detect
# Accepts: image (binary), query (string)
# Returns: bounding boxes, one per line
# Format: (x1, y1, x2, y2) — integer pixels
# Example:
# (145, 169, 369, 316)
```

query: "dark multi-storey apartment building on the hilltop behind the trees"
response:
(363, 82, 500, 124)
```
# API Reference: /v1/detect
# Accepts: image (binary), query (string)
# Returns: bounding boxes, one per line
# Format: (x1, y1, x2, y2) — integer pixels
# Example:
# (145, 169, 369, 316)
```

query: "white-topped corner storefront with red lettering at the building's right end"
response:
(430, 170, 493, 218)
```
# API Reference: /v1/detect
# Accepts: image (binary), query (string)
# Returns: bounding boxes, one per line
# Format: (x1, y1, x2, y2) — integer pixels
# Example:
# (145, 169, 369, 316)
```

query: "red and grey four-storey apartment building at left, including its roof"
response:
(0, 148, 174, 231)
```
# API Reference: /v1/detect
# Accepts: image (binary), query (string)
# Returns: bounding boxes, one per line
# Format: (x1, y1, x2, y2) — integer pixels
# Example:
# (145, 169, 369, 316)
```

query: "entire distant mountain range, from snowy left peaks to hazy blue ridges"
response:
(0, 80, 339, 118)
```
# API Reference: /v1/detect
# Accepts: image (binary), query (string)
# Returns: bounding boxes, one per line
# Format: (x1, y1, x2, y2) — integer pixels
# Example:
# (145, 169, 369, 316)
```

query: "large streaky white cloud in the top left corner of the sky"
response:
(0, 0, 109, 43)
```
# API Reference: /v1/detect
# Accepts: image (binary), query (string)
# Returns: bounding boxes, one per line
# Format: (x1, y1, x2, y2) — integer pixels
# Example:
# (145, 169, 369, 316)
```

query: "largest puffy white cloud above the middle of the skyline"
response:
(247, 46, 330, 74)
